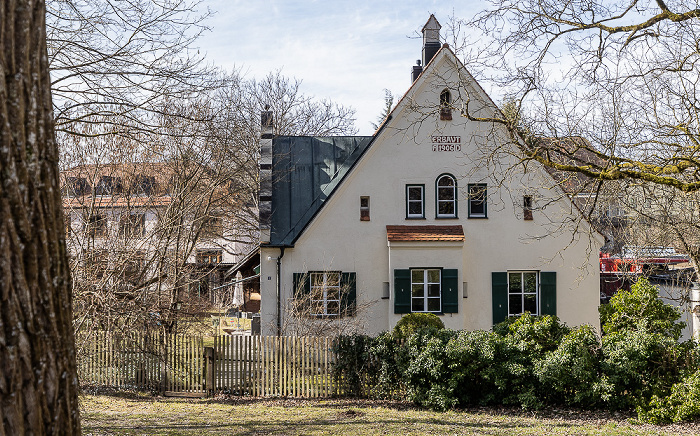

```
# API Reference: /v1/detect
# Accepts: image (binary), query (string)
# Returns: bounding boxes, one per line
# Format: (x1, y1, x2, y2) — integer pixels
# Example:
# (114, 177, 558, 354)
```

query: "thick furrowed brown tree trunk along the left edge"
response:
(0, 0, 80, 435)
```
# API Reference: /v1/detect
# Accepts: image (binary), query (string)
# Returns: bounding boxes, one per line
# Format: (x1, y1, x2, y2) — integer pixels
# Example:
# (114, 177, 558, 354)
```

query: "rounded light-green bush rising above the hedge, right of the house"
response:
(598, 277, 685, 341)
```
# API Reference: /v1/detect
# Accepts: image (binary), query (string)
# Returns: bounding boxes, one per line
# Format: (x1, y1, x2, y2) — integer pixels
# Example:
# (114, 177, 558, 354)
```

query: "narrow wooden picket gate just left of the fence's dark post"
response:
(161, 335, 207, 397)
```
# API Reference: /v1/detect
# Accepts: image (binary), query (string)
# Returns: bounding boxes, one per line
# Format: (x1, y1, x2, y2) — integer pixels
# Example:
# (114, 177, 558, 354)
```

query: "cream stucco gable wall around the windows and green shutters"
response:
(261, 54, 603, 334)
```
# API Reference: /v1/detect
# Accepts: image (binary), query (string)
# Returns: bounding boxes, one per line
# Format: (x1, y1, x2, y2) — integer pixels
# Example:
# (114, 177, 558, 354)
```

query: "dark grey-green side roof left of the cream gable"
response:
(270, 136, 373, 245)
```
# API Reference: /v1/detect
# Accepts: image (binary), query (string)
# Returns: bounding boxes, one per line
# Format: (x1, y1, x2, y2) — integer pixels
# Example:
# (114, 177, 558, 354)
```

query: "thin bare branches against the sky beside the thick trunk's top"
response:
(47, 0, 220, 136)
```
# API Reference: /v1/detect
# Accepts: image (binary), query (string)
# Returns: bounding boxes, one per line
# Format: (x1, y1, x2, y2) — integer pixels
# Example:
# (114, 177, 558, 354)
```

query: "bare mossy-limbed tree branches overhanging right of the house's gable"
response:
(457, 0, 700, 191)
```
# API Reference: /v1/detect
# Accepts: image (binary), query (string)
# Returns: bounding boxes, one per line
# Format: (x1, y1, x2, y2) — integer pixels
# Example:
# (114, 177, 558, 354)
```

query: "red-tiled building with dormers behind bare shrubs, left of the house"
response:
(61, 163, 257, 312)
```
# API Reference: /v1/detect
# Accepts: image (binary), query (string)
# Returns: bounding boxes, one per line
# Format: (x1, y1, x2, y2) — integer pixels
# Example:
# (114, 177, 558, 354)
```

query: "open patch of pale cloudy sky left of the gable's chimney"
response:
(198, 0, 483, 135)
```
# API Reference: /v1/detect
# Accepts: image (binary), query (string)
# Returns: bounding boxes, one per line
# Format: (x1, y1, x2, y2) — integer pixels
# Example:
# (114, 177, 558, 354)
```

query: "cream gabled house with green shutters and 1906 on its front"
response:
(254, 16, 604, 334)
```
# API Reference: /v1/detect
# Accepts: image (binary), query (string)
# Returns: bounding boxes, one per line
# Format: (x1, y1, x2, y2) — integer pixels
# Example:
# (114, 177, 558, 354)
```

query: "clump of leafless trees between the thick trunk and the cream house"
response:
(62, 72, 353, 338)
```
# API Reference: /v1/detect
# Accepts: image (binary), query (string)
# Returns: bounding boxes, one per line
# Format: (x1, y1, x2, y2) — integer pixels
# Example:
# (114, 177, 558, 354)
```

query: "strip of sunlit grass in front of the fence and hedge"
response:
(80, 393, 700, 436)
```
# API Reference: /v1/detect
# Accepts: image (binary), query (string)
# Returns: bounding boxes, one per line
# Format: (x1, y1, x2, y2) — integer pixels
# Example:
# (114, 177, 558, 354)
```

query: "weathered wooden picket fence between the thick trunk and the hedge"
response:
(78, 332, 341, 397)
